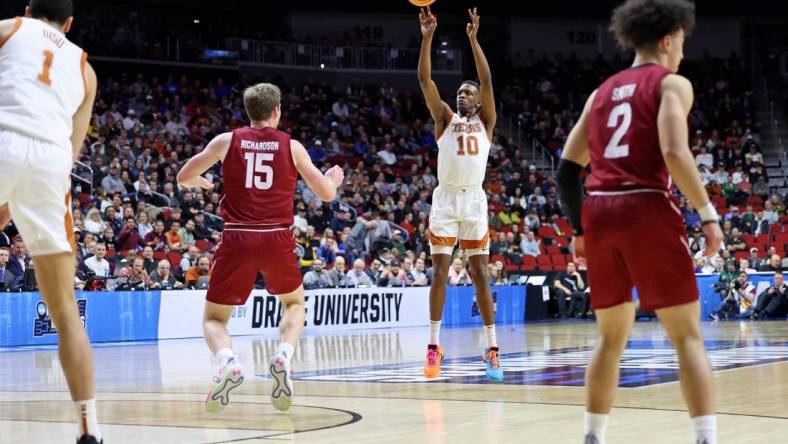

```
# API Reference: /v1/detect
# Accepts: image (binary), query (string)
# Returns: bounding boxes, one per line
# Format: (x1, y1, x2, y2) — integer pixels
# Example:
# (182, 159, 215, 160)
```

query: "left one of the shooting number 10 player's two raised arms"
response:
(418, 7, 452, 134)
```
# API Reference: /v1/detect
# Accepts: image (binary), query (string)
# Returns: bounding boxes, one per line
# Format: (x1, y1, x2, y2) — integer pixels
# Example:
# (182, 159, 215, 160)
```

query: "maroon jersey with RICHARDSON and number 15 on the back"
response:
(220, 127, 298, 229)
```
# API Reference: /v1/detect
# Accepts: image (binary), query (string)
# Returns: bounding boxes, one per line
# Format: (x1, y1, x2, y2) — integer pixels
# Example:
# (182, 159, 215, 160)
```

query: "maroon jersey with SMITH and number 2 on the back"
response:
(586, 64, 671, 191)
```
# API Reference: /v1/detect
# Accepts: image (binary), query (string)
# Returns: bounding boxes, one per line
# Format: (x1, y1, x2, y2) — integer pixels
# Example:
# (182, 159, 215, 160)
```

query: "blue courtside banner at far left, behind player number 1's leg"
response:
(0, 291, 161, 347)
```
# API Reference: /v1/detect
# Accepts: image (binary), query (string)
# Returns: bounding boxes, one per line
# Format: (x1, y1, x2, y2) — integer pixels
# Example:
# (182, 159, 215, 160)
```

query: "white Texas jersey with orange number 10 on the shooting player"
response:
(438, 113, 490, 188)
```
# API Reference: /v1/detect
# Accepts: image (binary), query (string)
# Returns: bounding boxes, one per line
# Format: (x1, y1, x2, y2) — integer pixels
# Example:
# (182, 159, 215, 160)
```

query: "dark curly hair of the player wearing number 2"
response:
(609, 0, 695, 49)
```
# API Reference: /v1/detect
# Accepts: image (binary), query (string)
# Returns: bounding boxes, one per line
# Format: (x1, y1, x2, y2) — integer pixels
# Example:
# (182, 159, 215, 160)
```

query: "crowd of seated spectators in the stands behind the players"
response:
(0, 50, 788, 315)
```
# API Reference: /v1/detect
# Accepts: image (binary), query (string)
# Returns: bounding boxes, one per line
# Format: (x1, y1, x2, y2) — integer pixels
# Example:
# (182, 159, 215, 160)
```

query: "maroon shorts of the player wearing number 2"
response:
(583, 192, 698, 311)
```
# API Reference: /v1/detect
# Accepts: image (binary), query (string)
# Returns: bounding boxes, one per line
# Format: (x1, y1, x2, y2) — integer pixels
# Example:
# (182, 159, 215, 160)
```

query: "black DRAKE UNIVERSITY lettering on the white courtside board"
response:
(252, 290, 403, 328)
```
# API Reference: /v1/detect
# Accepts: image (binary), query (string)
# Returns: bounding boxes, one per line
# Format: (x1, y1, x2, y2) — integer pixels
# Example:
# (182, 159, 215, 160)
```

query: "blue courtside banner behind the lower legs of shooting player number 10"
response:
(443, 286, 525, 326)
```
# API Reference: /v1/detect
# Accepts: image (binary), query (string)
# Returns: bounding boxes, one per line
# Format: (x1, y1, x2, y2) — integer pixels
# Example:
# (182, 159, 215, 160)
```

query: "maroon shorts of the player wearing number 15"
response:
(206, 229, 301, 305)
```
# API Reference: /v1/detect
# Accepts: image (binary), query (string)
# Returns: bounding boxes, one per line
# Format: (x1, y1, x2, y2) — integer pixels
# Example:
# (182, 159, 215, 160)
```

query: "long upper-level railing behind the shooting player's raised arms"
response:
(226, 38, 462, 73)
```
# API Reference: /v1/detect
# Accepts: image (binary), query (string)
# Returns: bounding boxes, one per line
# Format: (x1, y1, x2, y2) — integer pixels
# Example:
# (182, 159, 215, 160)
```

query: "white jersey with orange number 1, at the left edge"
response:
(0, 17, 87, 152)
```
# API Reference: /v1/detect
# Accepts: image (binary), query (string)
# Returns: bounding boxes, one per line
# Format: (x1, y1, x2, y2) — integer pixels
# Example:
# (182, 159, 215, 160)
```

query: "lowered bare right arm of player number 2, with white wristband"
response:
(657, 74, 722, 256)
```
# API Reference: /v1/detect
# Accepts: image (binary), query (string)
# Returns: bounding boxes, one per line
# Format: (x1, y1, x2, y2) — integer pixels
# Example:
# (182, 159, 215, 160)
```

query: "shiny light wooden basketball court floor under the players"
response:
(0, 321, 788, 444)
